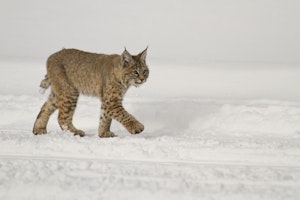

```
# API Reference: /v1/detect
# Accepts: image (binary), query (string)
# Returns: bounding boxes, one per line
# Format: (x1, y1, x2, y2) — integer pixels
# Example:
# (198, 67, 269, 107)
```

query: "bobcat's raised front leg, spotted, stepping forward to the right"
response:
(102, 100, 144, 134)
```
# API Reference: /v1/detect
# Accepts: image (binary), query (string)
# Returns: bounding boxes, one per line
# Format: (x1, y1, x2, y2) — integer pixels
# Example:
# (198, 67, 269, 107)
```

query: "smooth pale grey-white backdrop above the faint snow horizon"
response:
(0, 0, 300, 63)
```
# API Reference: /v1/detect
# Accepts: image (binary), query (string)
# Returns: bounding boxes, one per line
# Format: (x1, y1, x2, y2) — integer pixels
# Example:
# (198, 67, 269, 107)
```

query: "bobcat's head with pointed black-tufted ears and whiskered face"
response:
(121, 47, 149, 87)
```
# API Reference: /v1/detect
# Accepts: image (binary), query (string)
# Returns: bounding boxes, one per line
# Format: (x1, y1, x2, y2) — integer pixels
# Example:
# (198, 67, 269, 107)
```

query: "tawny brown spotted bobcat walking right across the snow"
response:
(33, 48, 149, 137)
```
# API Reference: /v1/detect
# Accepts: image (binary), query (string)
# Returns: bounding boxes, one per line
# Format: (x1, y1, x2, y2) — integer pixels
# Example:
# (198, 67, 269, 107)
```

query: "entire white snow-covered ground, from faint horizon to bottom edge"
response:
(0, 59, 300, 200)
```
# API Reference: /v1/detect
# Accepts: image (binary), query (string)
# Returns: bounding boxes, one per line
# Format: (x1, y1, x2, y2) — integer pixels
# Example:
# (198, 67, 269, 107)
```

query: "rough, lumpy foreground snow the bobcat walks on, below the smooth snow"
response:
(0, 95, 300, 199)
